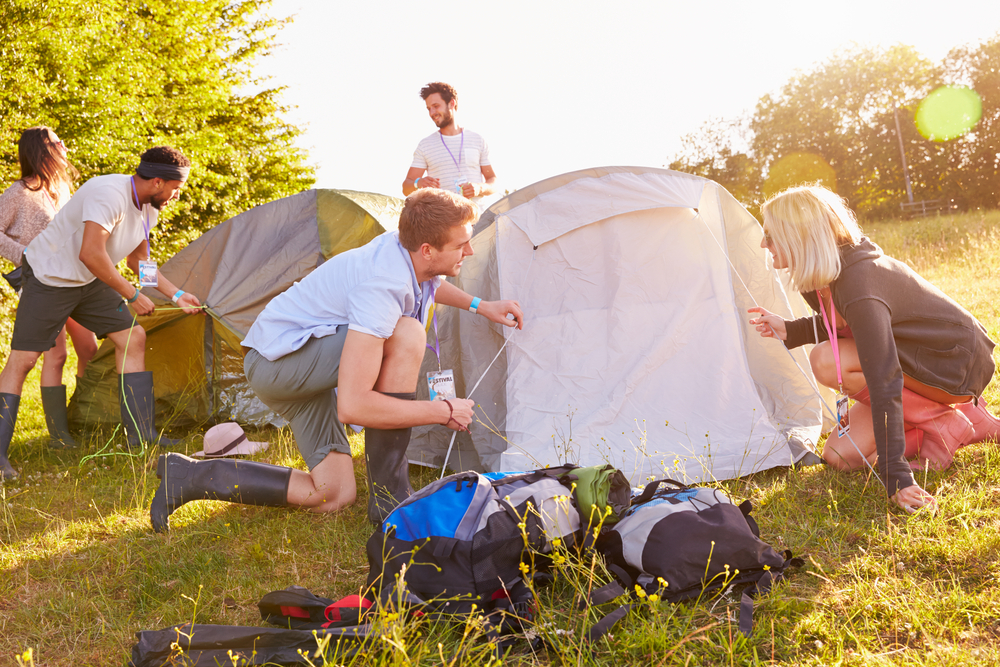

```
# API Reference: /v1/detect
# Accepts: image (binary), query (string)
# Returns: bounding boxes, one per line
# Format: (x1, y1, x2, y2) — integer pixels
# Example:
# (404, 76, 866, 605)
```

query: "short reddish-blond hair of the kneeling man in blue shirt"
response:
(399, 188, 479, 252)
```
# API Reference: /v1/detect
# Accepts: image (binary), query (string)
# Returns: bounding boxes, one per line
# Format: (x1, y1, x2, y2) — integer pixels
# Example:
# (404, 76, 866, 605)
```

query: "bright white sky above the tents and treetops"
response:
(258, 0, 1000, 206)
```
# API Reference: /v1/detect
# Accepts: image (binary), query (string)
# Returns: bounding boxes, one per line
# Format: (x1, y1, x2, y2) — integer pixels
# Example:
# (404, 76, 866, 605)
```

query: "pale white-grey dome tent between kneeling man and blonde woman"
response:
(409, 167, 822, 483)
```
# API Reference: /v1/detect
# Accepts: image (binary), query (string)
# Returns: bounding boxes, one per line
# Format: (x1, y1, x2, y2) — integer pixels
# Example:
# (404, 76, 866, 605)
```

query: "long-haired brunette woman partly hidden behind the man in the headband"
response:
(0, 127, 97, 448)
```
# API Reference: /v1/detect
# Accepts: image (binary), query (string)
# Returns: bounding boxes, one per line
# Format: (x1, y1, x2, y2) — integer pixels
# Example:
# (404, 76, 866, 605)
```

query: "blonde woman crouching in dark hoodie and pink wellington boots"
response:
(749, 186, 1000, 511)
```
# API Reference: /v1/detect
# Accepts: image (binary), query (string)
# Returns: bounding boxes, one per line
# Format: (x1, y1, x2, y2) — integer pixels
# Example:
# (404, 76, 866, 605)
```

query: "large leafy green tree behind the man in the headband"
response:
(0, 0, 314, 260)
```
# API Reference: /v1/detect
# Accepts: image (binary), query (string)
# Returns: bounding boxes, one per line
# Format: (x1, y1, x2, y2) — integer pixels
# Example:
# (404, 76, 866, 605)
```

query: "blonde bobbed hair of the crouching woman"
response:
(761, 185, 862, 292)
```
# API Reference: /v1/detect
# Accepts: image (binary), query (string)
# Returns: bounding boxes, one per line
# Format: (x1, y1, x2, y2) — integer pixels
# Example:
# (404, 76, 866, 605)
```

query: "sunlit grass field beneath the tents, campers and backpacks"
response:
(0, 212, 1000, 667)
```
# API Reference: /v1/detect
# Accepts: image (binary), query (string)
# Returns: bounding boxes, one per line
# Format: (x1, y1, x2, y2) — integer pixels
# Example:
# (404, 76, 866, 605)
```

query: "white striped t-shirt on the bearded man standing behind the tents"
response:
(410, 130, 490, 201)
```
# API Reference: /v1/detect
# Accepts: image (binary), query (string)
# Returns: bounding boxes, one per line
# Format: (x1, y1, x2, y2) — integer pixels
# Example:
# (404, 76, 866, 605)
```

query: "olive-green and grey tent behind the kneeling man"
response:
(69, 190, 403, 427)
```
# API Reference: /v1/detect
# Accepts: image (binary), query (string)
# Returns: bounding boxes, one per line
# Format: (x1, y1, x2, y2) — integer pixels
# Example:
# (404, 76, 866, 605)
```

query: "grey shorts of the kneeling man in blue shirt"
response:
(243, 325, 351, 470)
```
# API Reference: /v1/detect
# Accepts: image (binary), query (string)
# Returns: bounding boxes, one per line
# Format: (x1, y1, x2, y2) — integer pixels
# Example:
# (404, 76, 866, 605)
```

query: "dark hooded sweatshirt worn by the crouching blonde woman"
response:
(785, 238, 995, 496)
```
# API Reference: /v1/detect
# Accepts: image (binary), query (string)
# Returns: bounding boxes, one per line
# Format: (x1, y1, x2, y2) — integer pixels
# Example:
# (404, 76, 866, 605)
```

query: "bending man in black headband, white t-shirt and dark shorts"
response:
(0, 146, 201, 477)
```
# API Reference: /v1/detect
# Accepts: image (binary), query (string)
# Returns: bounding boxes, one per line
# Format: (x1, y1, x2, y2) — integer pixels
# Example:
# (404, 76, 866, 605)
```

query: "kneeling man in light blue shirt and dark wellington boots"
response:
(150, 188, 524, 532)
